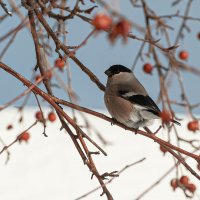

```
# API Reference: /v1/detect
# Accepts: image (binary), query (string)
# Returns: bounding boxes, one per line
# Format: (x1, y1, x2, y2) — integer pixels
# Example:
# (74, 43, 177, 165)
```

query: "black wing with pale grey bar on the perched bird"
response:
(119, 90, 160, 116)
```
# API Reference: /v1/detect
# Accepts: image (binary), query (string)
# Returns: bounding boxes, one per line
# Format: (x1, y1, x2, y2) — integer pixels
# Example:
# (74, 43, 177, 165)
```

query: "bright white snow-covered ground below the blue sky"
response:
(0, 109, 200, 200)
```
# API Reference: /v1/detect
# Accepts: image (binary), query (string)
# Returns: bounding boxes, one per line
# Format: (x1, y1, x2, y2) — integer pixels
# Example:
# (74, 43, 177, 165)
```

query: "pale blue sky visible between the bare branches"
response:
(0, 0, 200, 112)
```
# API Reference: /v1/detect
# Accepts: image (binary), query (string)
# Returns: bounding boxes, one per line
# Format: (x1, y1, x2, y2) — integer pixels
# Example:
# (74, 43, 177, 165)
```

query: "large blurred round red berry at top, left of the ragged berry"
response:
(92, 13, 112, 30)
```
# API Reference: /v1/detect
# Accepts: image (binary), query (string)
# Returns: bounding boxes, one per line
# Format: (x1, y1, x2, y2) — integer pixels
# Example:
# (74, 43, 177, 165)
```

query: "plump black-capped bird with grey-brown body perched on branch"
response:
(104, 64, 180, 129)
